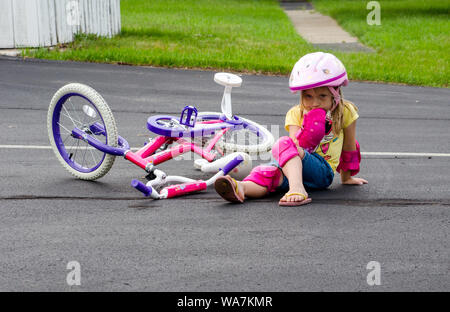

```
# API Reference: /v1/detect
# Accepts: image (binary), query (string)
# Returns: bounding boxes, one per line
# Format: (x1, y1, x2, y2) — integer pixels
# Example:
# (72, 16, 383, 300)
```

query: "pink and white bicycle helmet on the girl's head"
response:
(289, 52, 348, 110)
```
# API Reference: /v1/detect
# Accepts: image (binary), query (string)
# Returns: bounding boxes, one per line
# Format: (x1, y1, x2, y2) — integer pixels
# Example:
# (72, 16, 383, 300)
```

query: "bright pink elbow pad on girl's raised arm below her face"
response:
(295, 108, 327, 153)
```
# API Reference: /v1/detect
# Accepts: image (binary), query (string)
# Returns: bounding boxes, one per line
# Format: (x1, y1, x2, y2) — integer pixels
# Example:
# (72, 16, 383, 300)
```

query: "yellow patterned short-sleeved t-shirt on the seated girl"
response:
(284, 101, 359, 172)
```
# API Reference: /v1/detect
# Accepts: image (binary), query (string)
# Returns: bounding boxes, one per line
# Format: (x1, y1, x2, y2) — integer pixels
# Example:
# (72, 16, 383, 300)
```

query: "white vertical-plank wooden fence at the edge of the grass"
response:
(0, 0, 121, 48)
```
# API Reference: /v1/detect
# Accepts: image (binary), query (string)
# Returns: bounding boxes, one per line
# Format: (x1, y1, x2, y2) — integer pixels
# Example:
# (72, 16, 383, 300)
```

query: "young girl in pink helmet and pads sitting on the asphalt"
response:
(214, 52, 368, 206)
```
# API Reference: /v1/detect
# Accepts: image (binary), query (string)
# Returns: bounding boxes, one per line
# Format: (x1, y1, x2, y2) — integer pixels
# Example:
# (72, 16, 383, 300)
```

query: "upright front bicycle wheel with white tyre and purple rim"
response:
(47, 83, 118, 180)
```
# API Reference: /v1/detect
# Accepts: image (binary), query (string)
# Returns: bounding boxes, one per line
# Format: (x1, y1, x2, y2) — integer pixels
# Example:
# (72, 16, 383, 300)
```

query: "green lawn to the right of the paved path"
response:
(312, 0, 450, 87)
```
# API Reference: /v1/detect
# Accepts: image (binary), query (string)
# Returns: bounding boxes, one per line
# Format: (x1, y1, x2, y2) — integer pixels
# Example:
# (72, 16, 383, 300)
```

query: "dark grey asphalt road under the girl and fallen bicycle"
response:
(0, 58, 450, 291)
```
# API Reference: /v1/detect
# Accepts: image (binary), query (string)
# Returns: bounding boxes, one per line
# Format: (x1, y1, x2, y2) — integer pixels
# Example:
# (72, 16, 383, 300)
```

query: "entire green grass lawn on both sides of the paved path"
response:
(24, 0, 450, 87)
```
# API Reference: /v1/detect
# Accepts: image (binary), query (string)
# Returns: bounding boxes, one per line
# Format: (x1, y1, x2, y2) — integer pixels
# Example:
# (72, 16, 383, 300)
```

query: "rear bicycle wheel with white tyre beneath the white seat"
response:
(197, 112, 274, 154)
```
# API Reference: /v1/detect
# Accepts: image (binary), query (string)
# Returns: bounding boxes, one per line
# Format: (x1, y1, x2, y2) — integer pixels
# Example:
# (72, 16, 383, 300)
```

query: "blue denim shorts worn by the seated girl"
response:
(268, 151, 334, 192)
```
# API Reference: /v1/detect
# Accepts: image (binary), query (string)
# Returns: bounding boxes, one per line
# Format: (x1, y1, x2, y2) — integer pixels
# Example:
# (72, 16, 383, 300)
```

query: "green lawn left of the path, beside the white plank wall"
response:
(26, 0, 313, 74)
